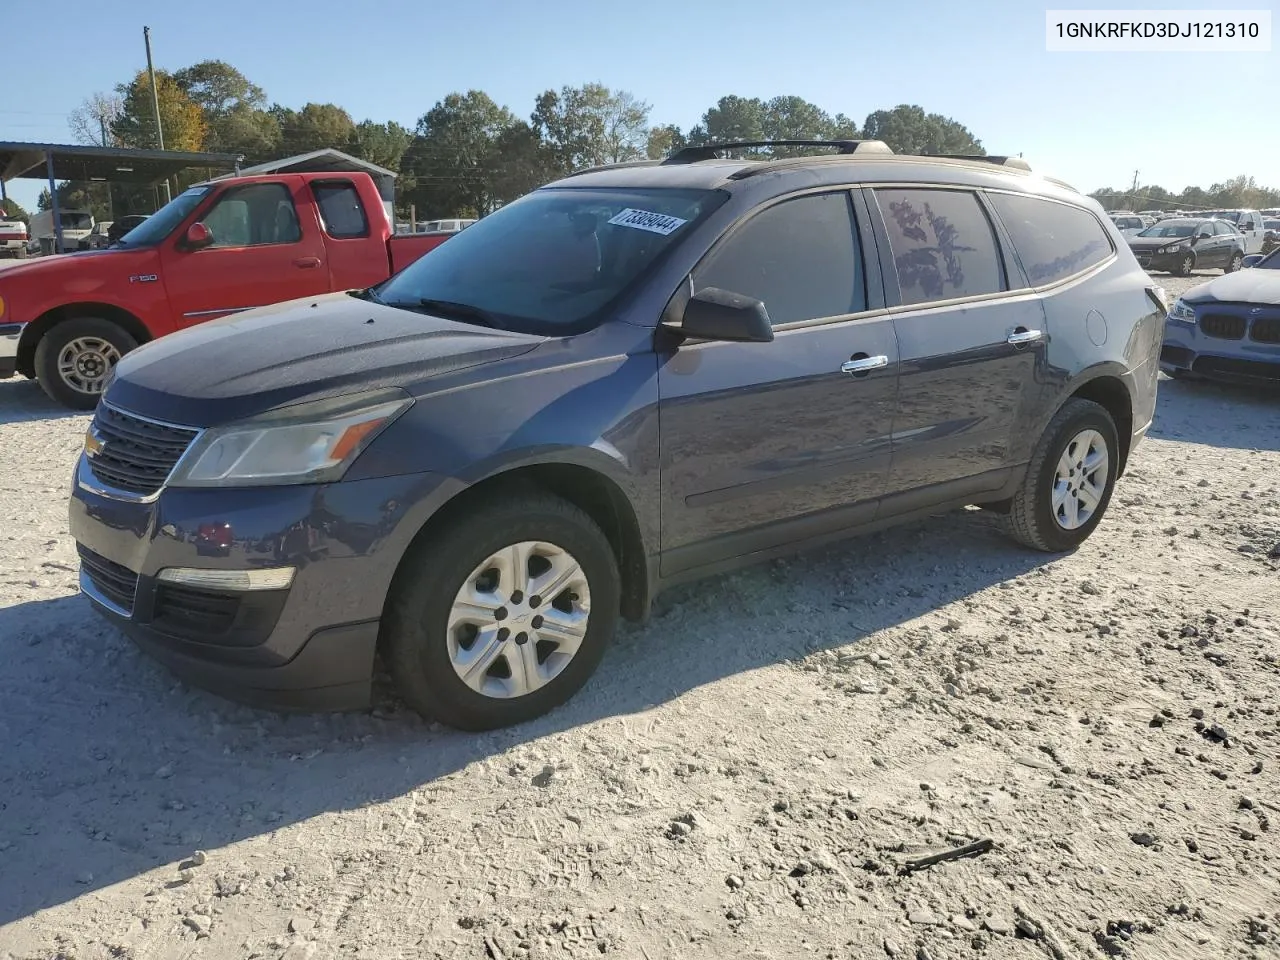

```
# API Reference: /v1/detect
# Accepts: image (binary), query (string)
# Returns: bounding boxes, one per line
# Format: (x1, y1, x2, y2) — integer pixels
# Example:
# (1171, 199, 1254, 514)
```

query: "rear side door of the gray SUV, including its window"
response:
(867, 186, 1048, 509)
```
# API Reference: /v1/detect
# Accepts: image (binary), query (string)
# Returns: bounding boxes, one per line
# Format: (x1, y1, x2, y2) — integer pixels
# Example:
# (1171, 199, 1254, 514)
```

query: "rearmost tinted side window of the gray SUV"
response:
(988, 193, 1111, 287)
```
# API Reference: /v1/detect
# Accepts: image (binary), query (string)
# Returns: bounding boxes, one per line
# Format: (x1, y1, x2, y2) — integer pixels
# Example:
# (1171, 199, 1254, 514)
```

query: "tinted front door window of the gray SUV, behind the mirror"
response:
(696, 191, 867, 324)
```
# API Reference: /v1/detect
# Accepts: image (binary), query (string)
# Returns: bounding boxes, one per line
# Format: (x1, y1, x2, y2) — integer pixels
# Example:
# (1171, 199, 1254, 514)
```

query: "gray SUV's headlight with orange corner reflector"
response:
(169, 388, 413, 486)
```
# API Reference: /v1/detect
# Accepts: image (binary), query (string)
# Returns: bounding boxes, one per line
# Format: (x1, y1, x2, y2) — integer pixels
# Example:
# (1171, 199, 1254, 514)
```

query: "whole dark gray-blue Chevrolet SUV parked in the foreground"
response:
(70, 141, 1165, 730)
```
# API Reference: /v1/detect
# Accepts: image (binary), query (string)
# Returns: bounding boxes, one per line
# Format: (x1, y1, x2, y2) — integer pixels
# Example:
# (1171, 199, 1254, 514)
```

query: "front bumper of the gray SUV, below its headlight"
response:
(69, 457, 450, 710)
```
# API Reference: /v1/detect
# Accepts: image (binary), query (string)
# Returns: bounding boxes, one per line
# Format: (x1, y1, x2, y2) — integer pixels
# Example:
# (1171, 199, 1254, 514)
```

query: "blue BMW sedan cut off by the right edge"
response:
(1160, 250, 1280, 385)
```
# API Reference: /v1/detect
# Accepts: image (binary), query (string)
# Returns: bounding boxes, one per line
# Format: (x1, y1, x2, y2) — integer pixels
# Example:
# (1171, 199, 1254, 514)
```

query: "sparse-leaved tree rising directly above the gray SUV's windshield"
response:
(531, 83, 650, 173)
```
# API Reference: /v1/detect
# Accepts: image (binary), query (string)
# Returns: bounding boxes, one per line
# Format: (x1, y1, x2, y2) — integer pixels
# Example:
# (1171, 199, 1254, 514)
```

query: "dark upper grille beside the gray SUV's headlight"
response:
(88, 403, 198, 495)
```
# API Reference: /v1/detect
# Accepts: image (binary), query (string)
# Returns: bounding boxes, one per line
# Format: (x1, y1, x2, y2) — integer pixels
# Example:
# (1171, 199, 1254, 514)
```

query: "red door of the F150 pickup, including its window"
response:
(161, 178, 329, 326)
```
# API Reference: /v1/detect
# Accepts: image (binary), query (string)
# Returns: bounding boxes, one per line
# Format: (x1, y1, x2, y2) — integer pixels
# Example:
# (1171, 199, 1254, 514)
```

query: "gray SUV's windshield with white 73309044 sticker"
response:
(374, 187, 727, 335)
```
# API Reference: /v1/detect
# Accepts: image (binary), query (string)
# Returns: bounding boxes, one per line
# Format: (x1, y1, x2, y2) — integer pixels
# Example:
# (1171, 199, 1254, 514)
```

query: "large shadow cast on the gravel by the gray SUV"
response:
(0, 511, 1050, 927)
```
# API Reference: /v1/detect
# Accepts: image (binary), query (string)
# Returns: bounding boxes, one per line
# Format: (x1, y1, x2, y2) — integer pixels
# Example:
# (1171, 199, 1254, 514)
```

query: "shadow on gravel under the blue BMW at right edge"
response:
(1151, 378, 1280, 451)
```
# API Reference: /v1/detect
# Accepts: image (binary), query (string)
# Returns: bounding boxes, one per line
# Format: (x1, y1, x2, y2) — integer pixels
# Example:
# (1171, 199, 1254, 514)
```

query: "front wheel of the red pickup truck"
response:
(36, 316, 138, 410)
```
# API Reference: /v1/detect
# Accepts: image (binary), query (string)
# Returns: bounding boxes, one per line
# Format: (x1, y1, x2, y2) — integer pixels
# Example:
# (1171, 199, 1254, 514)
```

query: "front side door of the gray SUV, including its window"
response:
(658, 189, 897, 576)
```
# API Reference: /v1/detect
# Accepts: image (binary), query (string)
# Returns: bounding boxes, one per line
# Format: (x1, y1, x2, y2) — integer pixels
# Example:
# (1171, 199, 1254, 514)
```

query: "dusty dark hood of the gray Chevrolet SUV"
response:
(106, 293, 545, 426)
